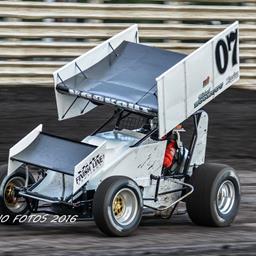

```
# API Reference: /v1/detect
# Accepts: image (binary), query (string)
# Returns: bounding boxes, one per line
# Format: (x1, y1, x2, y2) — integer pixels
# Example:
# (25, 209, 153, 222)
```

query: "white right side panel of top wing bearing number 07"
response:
(156, 22, 239, 138)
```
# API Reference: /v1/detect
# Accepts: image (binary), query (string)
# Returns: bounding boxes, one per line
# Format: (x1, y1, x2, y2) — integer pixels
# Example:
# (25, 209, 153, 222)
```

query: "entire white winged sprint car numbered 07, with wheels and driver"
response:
(0, 22, 240, 236)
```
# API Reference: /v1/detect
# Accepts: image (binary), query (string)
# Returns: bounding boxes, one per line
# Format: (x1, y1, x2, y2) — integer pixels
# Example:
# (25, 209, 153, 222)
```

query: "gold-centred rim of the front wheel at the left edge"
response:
(4, 177, 27, 213)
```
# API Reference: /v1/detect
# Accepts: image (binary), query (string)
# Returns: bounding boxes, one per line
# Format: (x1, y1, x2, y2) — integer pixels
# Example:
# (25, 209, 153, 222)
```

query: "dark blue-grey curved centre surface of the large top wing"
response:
(56, 41, 186, 116)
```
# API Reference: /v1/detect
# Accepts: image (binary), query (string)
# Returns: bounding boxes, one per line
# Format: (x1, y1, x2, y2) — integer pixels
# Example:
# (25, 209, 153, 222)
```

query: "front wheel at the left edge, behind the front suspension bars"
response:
(0, 165, 37, 224)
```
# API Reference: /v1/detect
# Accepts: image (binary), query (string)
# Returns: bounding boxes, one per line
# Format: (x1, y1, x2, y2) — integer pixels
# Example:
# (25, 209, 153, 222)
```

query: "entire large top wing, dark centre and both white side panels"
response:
(54, 22, 239, 138)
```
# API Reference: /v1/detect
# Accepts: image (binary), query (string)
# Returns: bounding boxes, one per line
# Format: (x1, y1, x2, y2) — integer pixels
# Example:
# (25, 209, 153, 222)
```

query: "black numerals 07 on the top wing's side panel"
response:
(215, 29, 238, 74)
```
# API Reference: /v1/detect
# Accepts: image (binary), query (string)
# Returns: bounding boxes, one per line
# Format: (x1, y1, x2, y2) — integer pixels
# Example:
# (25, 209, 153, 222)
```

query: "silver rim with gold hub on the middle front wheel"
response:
(112, 188, 138, 226)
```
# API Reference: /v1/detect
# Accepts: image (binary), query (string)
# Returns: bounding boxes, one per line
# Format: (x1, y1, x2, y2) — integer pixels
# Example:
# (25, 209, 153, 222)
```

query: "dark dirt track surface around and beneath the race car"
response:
(0, 88, 256, 256)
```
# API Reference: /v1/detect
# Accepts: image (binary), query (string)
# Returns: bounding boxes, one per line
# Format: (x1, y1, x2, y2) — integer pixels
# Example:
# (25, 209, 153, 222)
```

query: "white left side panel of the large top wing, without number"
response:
(53, 25, 138, 120)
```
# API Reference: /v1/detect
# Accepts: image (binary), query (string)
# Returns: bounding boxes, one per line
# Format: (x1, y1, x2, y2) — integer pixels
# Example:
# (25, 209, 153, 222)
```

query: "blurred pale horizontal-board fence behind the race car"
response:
(0, 0, 256, 89)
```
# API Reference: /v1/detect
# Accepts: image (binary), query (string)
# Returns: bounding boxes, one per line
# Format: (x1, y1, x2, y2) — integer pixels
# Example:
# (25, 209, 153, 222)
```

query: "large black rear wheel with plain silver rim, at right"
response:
(186, 164, 240, 227)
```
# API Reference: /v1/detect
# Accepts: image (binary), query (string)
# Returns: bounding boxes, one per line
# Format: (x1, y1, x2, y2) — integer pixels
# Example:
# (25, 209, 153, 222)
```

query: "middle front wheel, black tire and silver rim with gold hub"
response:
(93, 176, 143, 236)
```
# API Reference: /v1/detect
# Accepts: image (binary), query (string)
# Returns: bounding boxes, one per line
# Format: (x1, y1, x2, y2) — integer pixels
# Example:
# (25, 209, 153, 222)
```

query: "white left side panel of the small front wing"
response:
(8, 124, 43, 175)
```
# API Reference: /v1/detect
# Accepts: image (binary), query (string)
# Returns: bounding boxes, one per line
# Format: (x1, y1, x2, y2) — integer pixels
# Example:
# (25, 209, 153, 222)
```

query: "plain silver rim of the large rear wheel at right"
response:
(217, 180, 235, 214)
